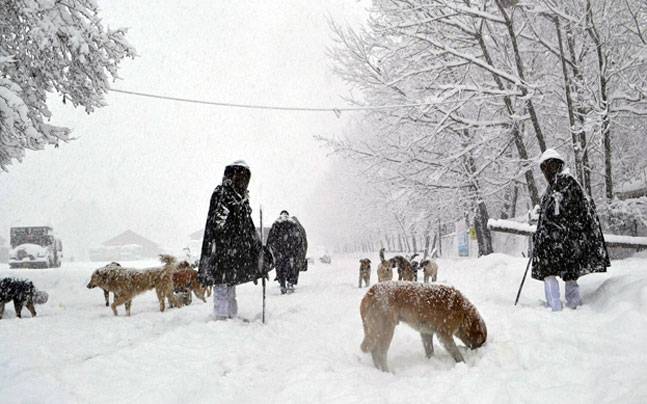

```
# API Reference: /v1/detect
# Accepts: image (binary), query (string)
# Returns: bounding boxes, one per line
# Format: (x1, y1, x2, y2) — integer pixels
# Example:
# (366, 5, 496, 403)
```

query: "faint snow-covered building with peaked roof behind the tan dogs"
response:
(90, 230, 162, 261)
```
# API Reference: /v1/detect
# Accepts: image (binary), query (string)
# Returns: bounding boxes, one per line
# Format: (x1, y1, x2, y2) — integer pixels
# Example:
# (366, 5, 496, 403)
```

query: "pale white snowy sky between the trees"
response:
(0, 0, 366, 258)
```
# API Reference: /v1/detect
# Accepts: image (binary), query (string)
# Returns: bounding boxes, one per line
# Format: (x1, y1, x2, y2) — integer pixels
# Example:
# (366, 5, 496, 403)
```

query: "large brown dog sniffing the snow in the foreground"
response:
(360, 282, 487, 372)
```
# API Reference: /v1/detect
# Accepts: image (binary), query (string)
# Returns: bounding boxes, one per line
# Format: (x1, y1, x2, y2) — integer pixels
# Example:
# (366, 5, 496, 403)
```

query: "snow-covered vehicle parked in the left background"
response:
(9, 226, 63, 268)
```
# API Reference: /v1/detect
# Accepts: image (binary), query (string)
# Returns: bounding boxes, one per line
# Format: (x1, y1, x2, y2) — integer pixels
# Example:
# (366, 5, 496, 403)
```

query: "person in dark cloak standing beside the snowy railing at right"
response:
(532, 149, 611, 311)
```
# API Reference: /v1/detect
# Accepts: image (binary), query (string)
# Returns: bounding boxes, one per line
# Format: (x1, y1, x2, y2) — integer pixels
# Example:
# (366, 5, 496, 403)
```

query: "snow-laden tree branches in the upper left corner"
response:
(0, 0, 135, 171)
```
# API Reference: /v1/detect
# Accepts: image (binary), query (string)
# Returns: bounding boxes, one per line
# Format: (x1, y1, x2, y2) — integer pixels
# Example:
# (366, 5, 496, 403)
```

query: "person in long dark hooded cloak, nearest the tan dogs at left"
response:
(198, 160, 266, 320)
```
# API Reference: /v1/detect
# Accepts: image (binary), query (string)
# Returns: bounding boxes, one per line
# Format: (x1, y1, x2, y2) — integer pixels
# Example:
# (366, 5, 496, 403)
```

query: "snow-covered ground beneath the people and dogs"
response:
(0, 254, 647, 404)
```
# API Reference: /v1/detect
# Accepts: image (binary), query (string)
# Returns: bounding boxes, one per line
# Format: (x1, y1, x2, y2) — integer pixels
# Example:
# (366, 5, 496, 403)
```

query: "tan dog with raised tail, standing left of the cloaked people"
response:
(87, 255, 177, 316)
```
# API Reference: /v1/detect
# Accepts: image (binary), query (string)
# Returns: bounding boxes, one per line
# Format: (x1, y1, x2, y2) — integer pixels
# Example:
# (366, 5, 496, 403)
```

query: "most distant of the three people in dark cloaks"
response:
(267, 210, 308, 294)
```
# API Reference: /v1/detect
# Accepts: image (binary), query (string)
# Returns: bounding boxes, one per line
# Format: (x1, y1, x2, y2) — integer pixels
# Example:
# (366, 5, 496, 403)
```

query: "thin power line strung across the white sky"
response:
(110, 88, 456, 118)
